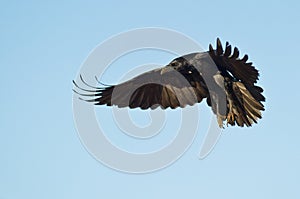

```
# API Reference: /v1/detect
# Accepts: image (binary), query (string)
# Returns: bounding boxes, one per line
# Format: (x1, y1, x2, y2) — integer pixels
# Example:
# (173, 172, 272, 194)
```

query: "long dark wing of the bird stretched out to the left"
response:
(73, 68, 208, 109)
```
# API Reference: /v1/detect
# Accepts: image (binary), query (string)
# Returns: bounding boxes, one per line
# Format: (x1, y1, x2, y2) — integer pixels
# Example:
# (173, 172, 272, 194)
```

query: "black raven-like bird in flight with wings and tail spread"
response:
(73, 38, 265, 128)
